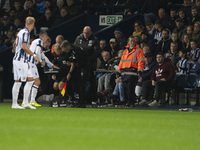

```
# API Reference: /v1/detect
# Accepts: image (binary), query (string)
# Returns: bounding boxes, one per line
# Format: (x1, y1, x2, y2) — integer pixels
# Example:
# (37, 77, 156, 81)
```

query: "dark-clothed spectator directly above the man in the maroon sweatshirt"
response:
(156, 29, 171, 53)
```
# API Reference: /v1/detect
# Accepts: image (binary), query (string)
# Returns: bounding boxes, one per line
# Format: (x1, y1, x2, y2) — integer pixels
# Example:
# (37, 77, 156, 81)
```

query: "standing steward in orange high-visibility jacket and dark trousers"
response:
(117, 36, 144, 106)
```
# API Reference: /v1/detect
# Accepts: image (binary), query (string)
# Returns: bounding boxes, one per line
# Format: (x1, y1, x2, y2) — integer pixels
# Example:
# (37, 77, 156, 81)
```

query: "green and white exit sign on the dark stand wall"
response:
(99, 15, 123, 26)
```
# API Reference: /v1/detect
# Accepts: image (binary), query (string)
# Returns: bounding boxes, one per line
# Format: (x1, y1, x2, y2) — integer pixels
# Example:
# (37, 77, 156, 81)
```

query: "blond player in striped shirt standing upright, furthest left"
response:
(12, 17, 38, 109)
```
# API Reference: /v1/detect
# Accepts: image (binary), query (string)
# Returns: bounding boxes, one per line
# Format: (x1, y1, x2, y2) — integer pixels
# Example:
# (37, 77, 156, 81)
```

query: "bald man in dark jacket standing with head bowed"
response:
(74, 26, 99, 103)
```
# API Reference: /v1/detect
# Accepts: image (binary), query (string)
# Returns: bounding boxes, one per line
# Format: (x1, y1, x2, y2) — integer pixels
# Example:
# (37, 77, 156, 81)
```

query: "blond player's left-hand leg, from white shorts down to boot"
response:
(12, 60, 23, 109)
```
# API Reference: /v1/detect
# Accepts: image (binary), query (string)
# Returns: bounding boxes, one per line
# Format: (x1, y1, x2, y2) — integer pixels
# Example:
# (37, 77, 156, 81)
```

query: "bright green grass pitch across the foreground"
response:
(0, 104, 200, 150)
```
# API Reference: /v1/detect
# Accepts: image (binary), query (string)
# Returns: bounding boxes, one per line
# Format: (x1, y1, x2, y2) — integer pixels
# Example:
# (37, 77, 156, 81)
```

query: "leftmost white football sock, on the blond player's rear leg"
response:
(12, 82, 22, 106)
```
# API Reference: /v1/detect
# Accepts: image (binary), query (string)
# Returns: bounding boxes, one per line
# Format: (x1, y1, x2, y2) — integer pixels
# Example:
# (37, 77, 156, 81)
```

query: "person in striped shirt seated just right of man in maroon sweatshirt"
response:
(176, 50, 187, 75)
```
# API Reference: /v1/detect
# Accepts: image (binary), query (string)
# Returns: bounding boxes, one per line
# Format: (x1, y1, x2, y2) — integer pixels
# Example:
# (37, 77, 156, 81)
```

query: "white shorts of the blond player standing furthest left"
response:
(13, 60, 32, 82)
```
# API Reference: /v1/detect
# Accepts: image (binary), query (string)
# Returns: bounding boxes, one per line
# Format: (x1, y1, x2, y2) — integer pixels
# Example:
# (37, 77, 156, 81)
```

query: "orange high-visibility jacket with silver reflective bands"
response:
(117, 44, 144, 71)
